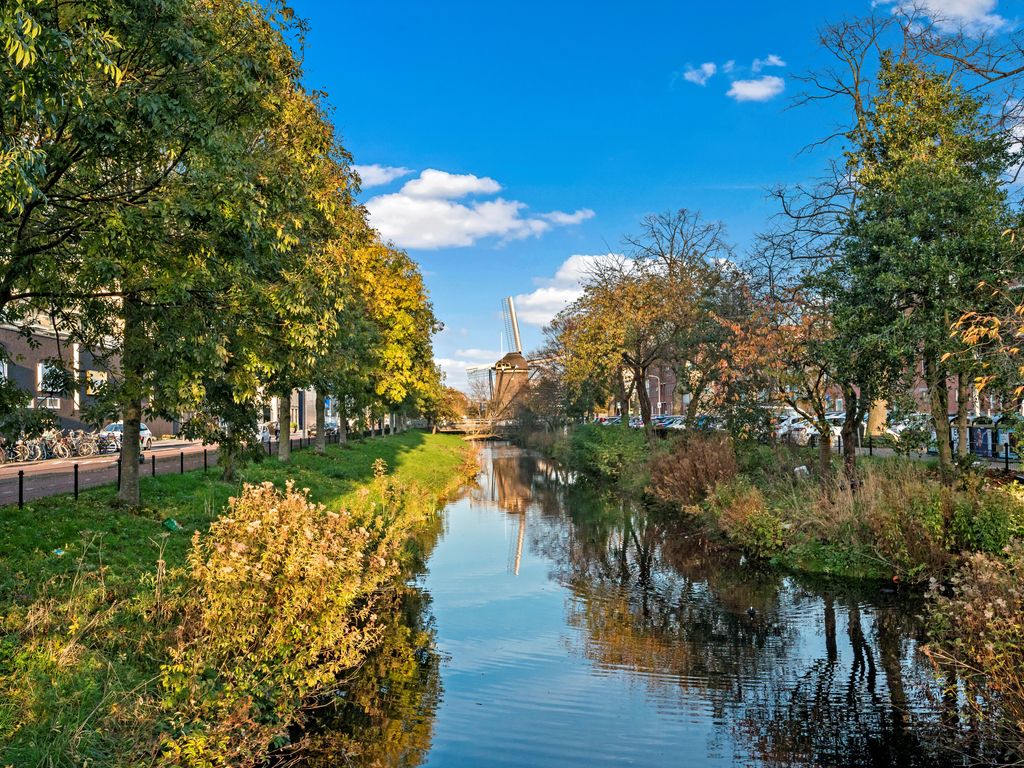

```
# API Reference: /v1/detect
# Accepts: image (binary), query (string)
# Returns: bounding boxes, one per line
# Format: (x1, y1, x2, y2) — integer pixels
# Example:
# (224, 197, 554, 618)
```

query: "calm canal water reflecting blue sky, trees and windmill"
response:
(309, 444, 995, 768)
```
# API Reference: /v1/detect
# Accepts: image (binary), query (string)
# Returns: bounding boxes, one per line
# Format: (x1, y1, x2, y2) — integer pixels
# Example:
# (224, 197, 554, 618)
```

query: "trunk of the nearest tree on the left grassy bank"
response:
(118, 297, 146, 507)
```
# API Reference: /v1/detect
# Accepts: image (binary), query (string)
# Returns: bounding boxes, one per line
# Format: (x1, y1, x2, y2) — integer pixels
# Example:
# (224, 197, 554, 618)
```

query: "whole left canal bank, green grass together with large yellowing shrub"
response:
(0, 432, 476, 766)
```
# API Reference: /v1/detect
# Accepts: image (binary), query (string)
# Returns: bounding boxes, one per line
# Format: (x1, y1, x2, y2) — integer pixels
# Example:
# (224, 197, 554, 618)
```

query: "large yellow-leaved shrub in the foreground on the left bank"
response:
(161, 480, 405, 766)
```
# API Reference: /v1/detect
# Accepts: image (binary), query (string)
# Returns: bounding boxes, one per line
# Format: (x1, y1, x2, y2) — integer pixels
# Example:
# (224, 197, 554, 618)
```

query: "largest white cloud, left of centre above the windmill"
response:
(367, 169, 594, 249)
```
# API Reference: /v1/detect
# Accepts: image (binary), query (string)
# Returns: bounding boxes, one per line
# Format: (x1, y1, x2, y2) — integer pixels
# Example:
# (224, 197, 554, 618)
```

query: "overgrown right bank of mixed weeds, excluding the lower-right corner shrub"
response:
(551, 426, 1024, 583)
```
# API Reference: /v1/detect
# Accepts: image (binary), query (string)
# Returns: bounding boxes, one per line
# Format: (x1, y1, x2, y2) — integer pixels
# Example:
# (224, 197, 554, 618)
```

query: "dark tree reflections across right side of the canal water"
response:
(503, 455, 999, 767)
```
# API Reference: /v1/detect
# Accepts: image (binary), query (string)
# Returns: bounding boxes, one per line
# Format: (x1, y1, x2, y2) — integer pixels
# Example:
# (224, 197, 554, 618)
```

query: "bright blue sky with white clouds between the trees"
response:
(294, 0, 1024, 386)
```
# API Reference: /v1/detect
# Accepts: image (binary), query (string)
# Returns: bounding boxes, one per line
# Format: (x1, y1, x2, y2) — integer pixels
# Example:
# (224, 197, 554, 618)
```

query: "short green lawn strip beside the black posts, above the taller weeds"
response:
(0, 431, 465, 606)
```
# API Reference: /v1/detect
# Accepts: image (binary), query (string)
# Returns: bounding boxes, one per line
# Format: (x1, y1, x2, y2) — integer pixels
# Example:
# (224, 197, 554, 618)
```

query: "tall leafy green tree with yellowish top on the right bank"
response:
(839, 54, 1010, 483)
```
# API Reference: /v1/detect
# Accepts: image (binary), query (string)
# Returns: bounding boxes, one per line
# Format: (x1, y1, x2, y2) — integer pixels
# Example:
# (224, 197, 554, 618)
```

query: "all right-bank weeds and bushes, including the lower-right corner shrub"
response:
(547, 425, 1024, 759)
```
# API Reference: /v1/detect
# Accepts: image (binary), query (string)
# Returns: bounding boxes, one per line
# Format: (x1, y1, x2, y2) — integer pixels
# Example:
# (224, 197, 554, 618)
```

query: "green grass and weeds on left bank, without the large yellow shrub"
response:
(0, 432, 468, 768)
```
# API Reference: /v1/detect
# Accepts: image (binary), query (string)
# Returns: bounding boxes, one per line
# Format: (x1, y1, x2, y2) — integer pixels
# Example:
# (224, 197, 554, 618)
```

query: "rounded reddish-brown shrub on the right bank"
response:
(649, 433, 736, 506)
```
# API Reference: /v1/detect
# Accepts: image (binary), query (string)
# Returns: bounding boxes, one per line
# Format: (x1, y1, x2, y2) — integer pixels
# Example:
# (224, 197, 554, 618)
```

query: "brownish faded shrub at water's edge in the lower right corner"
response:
(928, 541, 1024, 757)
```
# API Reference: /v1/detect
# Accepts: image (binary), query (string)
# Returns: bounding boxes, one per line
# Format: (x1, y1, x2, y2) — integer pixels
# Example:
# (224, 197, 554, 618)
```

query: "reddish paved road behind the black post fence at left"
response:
(0, 441, 217, 505)
